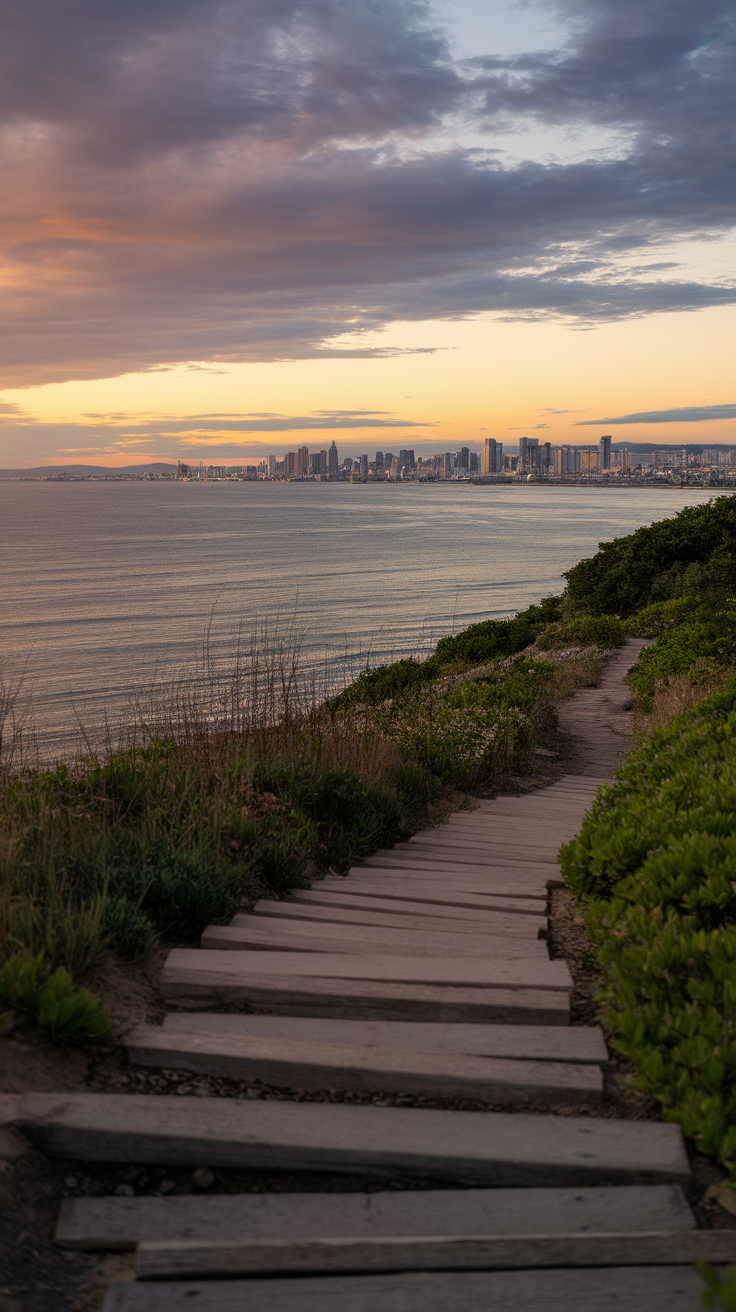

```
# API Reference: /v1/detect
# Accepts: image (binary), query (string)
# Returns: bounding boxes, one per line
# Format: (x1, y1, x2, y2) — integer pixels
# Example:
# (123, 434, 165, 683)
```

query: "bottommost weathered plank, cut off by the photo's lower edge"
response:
(102, 1266, 703, 1312)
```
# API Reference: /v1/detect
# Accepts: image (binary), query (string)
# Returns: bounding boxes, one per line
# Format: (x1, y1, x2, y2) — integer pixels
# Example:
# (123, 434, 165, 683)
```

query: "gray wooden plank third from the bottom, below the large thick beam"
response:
(55, 1185, 695, 1252)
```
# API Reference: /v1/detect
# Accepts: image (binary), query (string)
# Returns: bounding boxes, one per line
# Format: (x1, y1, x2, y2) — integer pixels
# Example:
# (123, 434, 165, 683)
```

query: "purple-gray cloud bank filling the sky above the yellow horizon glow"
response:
(0, 0, 736, 388)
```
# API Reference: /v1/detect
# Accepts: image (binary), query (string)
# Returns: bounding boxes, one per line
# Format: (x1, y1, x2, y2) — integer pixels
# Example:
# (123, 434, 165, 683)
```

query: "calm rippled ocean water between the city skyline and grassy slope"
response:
(0, 482, 711, 750)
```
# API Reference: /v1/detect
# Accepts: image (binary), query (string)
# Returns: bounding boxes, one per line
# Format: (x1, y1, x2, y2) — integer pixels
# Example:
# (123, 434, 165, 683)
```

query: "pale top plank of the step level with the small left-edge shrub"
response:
(161, 943, 572, 997)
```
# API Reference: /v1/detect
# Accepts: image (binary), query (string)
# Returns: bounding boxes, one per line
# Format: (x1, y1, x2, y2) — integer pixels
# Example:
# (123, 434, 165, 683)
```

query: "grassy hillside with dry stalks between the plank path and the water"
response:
(0, 600, 611, 1033)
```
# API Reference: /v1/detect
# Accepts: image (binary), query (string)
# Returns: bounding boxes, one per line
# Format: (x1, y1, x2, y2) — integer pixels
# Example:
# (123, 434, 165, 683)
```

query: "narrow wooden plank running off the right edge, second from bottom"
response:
(136, 1229, 736, 1281)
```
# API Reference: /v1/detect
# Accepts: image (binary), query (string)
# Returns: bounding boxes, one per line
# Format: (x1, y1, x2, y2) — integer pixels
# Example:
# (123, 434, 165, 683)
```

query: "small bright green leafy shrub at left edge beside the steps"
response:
(0, 955, 112, 1043)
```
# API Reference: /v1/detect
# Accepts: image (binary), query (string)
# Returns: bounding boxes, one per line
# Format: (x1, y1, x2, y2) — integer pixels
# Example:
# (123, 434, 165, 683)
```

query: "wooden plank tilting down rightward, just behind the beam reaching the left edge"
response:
(126, 1026, 603, 1107)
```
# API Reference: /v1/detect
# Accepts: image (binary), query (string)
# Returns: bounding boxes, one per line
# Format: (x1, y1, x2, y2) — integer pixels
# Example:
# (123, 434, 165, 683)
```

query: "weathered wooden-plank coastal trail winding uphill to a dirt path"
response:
(8, 640, 736, 1312)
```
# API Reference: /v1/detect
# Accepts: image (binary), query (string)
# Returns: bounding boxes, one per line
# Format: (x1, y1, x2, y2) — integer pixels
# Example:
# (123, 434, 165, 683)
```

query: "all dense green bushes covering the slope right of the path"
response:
(560, 499, 736, 1172)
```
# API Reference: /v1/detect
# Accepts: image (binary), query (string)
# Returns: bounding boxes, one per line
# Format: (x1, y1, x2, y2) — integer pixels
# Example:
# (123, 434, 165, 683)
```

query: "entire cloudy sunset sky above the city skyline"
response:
(0, 0, 736, 467)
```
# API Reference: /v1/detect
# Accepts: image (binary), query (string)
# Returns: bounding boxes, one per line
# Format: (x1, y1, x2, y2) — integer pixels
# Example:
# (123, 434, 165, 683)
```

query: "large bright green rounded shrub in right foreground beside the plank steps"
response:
(560, 681, 736, 1170)
